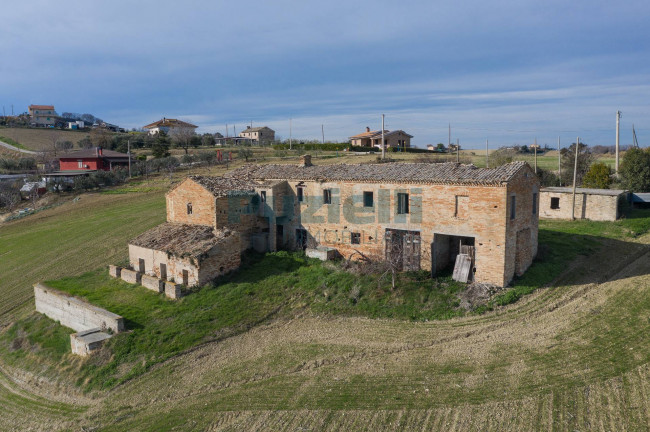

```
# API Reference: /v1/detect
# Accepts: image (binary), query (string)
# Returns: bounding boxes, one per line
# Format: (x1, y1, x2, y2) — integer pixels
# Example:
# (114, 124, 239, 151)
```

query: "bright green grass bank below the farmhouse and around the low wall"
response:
(0, 252, 464, 389)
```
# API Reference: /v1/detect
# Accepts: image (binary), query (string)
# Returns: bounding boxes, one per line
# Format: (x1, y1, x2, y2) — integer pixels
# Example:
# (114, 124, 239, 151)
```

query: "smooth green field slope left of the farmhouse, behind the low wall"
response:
(0, 192, 165, 323)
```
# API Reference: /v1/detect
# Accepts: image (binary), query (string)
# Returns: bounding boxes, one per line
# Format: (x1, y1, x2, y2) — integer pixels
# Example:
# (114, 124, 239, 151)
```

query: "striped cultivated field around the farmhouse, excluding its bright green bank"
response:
(0, 164, 650, 431)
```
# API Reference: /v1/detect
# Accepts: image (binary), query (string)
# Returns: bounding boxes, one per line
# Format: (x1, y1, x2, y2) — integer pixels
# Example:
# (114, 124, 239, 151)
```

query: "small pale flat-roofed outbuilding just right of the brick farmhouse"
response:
(539, 187, 629, 221)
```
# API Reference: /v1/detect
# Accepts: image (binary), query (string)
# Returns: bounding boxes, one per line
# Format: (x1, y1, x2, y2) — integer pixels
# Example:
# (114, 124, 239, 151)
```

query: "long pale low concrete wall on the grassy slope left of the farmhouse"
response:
(34, 283, 124, 333)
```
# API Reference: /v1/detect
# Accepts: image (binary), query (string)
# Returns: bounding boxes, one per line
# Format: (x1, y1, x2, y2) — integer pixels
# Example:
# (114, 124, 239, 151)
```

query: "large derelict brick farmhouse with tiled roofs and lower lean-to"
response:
(129, 155, 539, 286)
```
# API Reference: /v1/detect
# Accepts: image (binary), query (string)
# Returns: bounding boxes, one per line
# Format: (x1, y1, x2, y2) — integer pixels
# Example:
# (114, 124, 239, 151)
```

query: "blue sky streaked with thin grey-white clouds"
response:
(0, 0, 650, 148)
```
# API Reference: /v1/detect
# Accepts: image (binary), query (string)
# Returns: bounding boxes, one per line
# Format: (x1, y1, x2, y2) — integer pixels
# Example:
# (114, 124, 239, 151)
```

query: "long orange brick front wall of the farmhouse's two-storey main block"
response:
(256, 178, 537, 285)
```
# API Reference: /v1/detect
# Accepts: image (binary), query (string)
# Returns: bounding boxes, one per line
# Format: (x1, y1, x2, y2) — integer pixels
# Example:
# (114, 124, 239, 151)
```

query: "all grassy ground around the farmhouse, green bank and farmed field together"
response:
(0, 160, 650, 431)
